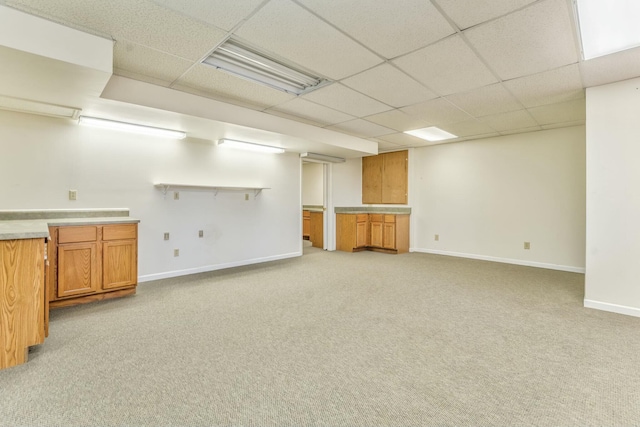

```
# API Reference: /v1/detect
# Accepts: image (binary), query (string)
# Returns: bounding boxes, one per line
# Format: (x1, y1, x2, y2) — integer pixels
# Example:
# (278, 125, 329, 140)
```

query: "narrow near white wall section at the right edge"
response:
(585, 79, 640, 316)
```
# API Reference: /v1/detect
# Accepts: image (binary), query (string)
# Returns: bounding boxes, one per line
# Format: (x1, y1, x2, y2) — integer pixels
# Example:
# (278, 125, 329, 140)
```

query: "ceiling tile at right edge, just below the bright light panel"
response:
(580, 47, 640, 87)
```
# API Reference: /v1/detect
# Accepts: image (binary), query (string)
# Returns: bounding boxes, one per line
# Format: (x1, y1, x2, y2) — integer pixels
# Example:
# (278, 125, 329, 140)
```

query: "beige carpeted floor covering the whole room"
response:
(0, 247, 640, 426)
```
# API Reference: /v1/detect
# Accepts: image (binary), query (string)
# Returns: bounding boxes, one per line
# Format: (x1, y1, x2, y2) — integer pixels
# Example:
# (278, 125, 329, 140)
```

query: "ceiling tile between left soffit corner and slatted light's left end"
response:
(113, 40, 193, 86)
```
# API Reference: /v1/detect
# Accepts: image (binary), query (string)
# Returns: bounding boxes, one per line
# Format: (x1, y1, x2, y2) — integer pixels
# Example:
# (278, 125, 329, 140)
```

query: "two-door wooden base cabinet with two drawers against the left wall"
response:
(48, 224, 138, 308)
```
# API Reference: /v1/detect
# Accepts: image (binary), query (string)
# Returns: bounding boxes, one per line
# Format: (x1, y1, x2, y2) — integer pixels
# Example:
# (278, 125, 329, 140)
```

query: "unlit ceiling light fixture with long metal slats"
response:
(202, 39, 331, 95)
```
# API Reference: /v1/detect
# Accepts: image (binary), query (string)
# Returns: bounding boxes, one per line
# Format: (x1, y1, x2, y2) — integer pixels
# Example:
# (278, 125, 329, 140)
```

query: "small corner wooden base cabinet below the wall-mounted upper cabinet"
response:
(336, 214, 409, 254)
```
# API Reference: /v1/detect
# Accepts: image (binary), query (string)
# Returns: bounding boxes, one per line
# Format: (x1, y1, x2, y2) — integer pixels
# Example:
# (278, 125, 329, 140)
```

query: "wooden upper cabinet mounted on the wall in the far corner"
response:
(362, 150, 409, 205)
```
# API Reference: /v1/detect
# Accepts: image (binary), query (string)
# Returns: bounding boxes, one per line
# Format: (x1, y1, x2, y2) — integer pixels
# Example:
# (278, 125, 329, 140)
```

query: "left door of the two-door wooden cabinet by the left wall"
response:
(57, 243, 100, 298)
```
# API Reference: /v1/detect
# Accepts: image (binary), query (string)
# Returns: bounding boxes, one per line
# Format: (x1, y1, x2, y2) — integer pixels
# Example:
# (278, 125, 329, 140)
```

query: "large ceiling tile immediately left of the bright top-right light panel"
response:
(464, 0, 578, 80)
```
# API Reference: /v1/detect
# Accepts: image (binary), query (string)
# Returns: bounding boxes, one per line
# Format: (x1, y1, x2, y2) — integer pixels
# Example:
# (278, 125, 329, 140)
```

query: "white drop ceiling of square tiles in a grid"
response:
(0, 0, 640, 154)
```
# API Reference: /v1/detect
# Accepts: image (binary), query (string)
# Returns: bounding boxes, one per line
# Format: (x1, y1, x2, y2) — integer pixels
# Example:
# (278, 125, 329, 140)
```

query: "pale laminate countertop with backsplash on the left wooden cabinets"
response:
(0, 209, 140, 240)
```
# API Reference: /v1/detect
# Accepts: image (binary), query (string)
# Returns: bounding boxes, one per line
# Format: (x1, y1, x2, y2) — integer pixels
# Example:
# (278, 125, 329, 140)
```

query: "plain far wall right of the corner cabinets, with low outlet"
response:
(409, 126, 585, 271)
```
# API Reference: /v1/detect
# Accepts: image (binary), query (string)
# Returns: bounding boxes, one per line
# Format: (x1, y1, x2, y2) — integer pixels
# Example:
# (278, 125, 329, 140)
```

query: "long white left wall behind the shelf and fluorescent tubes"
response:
(0, 111, 302, 280)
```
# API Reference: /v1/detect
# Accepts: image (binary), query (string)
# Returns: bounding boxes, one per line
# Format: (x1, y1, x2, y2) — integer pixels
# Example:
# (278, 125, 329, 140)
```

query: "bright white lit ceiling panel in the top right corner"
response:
(573, 0, 640, 59)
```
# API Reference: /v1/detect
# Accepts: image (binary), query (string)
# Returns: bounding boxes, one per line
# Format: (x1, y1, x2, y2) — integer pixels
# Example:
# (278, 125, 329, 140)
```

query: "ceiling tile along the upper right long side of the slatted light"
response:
(236, 0, 382, 80)
